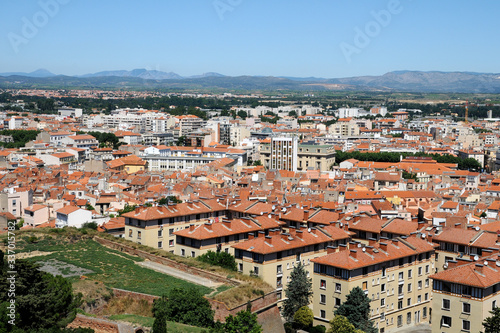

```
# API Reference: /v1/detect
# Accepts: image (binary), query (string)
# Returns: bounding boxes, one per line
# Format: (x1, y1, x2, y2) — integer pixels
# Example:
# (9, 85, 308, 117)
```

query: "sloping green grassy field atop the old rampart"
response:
(16, 235, 212, 296)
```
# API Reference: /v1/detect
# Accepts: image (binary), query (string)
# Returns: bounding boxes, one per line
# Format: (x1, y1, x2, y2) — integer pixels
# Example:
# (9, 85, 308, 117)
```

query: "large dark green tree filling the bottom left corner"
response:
(0, 259, 81, 332)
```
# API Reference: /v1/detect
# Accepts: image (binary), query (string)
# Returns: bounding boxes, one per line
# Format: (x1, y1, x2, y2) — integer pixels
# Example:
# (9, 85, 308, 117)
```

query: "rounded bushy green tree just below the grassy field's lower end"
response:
(153, 288, 214, 327)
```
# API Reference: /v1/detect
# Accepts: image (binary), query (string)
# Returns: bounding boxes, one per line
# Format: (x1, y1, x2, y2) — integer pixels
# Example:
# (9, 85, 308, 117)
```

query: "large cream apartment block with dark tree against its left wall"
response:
(312, 234, 434, 333)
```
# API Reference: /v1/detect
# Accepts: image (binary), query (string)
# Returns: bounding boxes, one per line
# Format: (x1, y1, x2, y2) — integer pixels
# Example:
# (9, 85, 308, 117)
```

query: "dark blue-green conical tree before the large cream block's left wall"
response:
(335, 287, 378, 333)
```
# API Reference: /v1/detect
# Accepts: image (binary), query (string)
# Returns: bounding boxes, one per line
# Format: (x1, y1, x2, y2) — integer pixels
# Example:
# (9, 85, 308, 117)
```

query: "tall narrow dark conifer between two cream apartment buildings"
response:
(282, 262, 313, 322)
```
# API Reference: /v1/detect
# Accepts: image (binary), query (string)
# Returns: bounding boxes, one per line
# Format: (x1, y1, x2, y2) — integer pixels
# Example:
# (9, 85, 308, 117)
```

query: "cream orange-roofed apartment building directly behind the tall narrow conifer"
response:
(233, 227, 350, 298)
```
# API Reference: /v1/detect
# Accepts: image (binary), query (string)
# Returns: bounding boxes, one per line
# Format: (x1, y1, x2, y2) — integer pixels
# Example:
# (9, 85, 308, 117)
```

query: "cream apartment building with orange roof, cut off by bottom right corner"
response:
(431, 250, 500, 333)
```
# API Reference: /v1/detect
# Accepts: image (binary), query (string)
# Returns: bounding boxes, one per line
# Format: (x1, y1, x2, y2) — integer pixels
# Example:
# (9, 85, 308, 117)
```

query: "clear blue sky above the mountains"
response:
(0, 0, 500, 77)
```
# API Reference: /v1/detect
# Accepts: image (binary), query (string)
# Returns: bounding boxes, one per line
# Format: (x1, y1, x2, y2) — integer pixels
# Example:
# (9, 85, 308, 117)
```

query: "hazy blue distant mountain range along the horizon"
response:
(0, 69, 500, 93)
